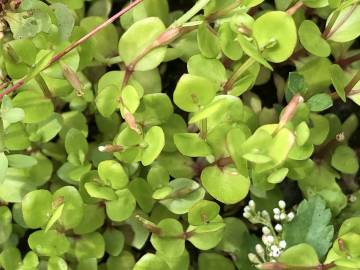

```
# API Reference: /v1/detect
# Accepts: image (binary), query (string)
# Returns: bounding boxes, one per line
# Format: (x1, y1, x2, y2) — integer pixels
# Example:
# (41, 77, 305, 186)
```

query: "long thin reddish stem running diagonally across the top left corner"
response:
(0, 0, 144, 100)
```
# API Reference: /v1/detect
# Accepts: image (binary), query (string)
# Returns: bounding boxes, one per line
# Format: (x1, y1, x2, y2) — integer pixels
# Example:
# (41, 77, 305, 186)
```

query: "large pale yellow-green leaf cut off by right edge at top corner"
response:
(326, 4, 360, 42)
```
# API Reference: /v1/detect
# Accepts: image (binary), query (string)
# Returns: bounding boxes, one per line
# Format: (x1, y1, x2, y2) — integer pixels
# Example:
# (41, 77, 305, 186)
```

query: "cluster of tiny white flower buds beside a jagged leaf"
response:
(243, 200, 295, 264)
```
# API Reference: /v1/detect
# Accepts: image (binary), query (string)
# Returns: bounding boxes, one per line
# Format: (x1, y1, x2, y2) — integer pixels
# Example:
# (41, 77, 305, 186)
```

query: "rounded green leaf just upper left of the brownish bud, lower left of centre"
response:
(105, 189, 136, 222)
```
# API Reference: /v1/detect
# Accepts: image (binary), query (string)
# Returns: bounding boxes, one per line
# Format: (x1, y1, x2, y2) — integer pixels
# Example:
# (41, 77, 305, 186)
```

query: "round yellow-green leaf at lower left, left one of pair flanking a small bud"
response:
(22, 189, 53, 228)
